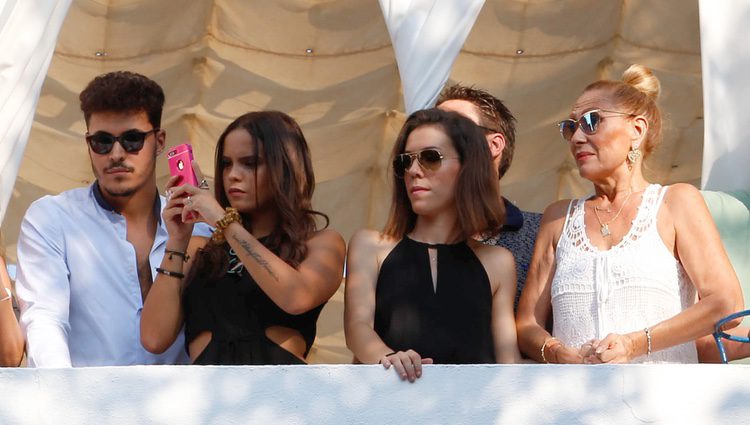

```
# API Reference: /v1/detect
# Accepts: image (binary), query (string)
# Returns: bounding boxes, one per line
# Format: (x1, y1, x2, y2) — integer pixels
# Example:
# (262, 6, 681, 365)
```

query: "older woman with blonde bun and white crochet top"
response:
(517, 65, 743, 363)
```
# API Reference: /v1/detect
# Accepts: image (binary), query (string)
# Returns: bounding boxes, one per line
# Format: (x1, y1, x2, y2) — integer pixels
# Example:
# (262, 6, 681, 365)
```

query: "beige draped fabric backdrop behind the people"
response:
(3, 0, 703, 257)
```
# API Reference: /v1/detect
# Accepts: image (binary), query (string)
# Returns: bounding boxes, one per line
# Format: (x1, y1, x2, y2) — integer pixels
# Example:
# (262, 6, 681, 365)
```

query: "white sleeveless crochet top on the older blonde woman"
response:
(551, 184, 698, 363)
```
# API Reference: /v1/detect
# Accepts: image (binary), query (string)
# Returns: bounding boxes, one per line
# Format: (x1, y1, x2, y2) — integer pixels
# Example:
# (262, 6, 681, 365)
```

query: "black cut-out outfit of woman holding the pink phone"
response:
(182, 245, 325, 365)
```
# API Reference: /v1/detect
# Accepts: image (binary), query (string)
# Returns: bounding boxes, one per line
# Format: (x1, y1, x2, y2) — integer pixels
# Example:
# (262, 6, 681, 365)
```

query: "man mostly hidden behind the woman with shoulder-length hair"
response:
(437, 84, 542, 306)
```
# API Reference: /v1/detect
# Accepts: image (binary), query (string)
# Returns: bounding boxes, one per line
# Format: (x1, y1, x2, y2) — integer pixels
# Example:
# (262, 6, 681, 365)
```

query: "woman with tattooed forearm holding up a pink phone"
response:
(141, 111, 345, 365)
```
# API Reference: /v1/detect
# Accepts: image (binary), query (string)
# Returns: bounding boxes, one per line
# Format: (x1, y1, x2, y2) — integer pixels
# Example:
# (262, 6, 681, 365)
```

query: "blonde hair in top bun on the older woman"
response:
(584, 64, 662, 158)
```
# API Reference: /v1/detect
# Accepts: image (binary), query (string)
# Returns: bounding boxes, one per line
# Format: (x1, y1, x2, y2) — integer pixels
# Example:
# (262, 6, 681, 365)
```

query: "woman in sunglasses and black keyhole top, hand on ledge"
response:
(344, 109, 520, 382)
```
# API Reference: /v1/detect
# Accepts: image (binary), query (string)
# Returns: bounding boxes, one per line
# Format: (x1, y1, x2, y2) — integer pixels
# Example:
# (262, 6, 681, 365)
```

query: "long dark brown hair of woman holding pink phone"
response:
(191, 111, 328, 277)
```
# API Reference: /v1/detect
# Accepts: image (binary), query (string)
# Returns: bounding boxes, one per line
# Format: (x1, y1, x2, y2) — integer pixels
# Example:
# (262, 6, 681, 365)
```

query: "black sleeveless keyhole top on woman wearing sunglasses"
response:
(375, 237, 495, 364)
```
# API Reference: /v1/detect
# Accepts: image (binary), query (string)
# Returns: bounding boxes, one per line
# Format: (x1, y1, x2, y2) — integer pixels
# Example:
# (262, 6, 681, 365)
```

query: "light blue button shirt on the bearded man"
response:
(16, 183, 210, 367)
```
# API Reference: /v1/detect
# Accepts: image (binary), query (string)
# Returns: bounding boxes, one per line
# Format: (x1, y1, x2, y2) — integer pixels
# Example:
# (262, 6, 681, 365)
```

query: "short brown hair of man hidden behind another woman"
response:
(437, 84, 516, 178)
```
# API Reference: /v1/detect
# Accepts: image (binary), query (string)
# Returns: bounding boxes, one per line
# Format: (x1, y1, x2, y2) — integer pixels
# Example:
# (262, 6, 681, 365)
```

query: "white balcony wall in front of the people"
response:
(0, 365, 750, 425)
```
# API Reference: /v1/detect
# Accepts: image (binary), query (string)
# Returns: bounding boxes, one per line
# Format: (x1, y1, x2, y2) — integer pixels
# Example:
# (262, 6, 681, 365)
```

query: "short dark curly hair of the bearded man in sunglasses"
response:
(79, 71, 164, 128)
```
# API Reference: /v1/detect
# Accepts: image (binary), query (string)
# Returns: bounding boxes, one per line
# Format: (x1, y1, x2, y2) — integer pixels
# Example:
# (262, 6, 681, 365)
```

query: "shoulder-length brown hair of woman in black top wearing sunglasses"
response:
(383, 109, 505, 239)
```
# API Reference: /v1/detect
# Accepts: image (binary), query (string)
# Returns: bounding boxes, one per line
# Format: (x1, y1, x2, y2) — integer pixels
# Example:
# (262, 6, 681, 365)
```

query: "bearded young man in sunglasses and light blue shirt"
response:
(17, 72, 208, 367)
